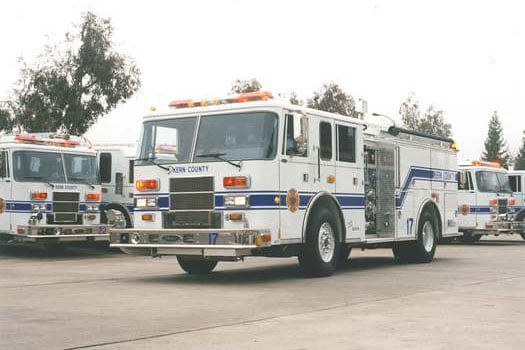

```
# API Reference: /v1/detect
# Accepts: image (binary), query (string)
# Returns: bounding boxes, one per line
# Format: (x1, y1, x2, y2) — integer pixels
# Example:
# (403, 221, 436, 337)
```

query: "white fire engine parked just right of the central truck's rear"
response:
(458, 160, 524, 242)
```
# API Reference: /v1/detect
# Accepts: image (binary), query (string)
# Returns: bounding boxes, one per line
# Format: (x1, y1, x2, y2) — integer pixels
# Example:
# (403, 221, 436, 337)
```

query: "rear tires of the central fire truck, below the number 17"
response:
(392, 210, 439, 263)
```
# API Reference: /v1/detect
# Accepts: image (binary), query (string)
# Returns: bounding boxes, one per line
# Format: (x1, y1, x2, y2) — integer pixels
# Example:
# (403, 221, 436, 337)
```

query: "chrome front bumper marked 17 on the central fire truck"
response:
(110, 228, 271, 257)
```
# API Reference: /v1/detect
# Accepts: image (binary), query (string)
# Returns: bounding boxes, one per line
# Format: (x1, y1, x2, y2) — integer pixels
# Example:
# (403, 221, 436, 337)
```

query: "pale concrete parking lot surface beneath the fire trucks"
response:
(0, 236, 525, 349)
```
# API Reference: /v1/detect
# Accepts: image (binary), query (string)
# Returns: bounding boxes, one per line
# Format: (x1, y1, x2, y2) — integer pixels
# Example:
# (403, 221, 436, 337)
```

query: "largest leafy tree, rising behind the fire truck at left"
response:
(13, 12, 140, 134)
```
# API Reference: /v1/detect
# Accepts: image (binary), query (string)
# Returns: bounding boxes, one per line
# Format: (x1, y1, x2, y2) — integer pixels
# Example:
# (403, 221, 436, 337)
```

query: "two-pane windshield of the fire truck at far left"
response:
(13, 151, 99, 184)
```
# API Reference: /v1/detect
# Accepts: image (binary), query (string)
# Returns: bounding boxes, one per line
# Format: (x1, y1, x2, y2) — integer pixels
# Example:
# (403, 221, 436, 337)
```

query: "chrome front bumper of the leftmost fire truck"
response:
(11, 225, 109, 243)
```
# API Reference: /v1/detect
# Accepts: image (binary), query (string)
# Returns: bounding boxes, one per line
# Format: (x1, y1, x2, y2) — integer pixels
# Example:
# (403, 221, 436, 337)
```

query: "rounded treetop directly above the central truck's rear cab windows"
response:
(307, 82, 355, 117)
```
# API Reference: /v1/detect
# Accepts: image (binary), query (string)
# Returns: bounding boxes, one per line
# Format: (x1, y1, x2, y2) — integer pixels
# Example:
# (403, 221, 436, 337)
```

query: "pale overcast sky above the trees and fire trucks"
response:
(0, 0, 525, 159)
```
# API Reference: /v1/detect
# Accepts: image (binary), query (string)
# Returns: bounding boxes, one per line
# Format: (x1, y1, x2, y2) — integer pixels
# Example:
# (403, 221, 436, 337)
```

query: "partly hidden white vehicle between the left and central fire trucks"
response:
(93, 144, 136, 228)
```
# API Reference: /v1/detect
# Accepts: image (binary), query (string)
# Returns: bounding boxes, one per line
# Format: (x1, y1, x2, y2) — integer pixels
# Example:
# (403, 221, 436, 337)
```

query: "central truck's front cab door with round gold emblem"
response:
(278, 112, 317, 243)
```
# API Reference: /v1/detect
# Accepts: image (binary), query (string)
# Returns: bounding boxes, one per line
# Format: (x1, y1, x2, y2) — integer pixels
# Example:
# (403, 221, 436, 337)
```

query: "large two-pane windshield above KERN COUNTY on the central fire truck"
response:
(137, 112, 278, 165)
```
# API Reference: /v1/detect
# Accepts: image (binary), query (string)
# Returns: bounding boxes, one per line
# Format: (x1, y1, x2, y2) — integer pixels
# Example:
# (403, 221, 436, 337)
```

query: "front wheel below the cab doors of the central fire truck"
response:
(299, 207, 340, 277)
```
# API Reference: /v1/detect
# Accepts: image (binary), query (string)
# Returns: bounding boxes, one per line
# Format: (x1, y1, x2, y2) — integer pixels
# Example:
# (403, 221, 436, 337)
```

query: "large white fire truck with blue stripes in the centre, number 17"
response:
(111, 92, 458, 276)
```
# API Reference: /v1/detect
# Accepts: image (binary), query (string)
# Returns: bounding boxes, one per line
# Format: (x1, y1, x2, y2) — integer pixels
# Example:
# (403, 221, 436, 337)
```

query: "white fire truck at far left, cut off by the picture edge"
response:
(0, 134, 109, 251)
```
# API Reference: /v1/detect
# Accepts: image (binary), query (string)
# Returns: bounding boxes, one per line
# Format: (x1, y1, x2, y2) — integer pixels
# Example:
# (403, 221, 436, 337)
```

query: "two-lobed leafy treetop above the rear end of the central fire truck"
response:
(399, 94, 452, 137)
